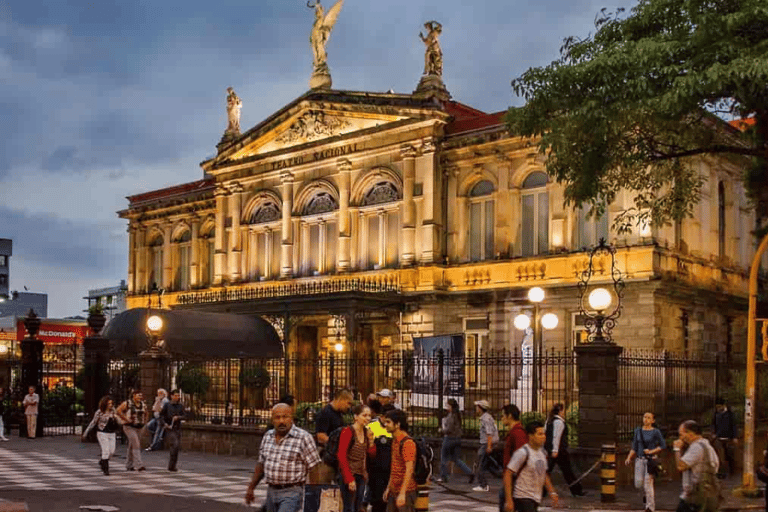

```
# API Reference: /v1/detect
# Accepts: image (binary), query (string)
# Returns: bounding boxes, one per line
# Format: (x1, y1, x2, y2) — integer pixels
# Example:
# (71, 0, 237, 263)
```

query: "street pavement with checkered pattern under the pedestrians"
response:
(0, 436, 764, 512)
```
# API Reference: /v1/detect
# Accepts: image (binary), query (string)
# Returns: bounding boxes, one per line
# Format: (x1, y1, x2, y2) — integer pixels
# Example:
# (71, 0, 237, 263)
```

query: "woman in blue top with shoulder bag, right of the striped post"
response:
(624, 412, 667, 512)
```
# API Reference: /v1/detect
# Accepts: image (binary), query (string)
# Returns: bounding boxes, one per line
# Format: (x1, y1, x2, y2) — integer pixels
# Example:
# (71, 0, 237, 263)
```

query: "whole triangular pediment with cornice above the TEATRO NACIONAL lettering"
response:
(206, 91, 450, 168)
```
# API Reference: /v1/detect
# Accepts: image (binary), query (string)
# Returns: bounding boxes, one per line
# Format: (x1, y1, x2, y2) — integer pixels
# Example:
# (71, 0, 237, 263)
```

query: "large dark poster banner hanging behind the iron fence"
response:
(411, 334, 465, 409)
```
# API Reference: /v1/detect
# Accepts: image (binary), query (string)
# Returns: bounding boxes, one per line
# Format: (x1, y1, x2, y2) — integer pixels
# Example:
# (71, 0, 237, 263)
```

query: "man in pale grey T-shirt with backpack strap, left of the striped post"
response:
(504, 421, 559, 512)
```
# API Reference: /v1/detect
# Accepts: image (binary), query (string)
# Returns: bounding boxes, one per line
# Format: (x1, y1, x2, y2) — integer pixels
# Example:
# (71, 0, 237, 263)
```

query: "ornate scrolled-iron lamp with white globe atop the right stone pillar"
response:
(579, 238, 624, 344)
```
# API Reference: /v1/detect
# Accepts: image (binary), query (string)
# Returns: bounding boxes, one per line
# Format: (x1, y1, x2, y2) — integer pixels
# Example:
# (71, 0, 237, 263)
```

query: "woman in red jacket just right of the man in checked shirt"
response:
(337, 405, 376, 512)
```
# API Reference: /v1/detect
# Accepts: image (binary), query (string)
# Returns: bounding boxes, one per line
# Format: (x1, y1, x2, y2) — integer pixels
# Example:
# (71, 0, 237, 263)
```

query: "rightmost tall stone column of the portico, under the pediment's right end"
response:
(419, 139, 441, 263)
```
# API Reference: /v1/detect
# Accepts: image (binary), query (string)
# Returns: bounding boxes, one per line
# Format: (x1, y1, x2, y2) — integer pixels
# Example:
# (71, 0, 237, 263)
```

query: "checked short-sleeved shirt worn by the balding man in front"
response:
(259, 425, 320, 485)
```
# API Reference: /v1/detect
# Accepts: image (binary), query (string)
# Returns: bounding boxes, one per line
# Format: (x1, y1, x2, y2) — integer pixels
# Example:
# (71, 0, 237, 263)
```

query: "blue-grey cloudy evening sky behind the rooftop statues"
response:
(0, 0, 620, 317)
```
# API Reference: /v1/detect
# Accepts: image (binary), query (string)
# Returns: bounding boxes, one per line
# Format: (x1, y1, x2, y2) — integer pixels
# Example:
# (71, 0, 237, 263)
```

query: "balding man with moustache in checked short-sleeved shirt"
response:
(245, 403, 320, 512)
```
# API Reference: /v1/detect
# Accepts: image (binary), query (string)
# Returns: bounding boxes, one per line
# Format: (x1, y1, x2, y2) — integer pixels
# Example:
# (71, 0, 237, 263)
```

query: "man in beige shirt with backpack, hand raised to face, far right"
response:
(673, 420, 721, 512)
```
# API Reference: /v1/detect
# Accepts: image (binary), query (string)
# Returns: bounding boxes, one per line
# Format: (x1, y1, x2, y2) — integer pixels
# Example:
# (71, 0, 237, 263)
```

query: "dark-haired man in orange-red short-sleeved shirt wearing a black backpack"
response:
(384, 409, 418, 512)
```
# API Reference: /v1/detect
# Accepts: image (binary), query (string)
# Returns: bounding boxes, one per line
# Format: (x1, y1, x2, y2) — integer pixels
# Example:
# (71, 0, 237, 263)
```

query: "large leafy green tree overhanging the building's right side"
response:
(507, 0, 768, 231)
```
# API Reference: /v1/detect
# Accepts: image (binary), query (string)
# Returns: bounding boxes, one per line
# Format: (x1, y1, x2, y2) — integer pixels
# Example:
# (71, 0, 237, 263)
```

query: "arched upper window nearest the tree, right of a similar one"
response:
(520, 171, 549, 256)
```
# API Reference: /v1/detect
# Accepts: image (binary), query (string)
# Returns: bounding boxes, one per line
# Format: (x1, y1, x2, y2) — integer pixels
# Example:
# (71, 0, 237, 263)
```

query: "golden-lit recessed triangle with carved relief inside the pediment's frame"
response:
(230, 108, 408, 160)
